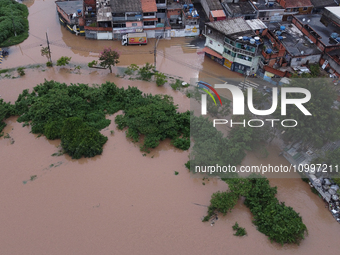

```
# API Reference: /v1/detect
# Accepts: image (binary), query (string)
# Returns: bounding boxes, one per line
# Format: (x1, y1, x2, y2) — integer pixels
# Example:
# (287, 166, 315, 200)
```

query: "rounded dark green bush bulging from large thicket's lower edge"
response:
(61, 117, 107, 159)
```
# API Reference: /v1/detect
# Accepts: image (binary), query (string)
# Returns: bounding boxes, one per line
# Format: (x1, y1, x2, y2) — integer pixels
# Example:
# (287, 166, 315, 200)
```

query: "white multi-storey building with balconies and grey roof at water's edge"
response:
(204, 18, 267, 75)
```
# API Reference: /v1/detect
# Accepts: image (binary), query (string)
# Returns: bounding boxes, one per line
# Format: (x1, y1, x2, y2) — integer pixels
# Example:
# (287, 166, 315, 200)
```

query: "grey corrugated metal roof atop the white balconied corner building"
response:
(207, 18, 252, 35)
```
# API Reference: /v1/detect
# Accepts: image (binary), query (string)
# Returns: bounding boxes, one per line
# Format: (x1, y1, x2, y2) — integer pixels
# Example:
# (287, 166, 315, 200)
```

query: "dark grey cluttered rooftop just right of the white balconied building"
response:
(268, 21, 321, 57)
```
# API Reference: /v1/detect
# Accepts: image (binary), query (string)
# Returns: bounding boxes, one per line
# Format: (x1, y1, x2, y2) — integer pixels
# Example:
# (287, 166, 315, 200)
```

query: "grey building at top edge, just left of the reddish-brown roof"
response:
(253, 0, 285, 22)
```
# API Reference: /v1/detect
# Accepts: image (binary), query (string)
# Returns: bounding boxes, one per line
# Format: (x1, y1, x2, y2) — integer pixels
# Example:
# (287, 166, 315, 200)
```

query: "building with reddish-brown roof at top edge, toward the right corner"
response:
(278, 0, 313, 21)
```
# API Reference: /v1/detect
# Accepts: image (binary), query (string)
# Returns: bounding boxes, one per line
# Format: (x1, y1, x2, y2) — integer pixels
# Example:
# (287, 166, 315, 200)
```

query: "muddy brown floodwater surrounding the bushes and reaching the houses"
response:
(0, 0, 340, 255)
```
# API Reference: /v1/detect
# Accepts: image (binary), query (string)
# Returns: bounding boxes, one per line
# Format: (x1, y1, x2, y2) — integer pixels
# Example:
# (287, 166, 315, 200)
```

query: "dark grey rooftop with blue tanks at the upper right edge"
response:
(295, 14, 340, 46)
